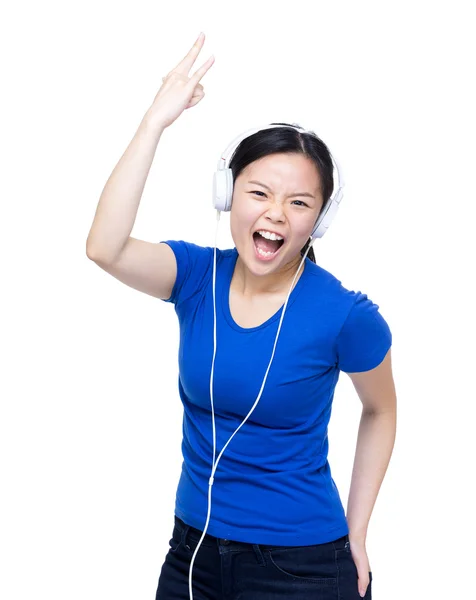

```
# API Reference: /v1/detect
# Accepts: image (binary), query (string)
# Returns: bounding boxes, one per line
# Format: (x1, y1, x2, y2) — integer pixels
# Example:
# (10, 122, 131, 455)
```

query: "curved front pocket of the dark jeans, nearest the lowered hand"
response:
(268, 546, 337, 585)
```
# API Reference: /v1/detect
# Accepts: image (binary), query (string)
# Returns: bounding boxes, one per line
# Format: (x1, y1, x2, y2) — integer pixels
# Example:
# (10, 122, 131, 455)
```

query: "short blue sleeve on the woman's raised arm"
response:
(162, 240, 213, 306)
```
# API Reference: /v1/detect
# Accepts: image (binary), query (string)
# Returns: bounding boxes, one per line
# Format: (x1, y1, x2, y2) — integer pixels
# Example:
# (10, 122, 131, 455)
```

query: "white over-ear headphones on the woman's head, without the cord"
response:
(213, 124, 344, 240)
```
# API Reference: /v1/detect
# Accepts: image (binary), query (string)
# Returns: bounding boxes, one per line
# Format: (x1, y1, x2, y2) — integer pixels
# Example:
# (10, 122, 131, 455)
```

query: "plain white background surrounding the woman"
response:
(0, 0, 476, 600)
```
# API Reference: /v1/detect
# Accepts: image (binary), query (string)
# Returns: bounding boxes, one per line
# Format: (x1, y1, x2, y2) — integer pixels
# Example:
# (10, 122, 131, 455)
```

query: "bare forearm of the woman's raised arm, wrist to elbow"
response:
(86, 114, 164, 261)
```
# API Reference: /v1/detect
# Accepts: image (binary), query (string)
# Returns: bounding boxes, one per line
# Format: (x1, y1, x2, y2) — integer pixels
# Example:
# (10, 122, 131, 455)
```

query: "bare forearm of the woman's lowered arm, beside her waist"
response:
(347, 410, 396, 541)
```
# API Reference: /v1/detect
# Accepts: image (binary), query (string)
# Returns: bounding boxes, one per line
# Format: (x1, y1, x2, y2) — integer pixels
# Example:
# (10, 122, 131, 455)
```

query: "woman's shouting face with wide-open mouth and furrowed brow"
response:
(230, 153, 323, 275)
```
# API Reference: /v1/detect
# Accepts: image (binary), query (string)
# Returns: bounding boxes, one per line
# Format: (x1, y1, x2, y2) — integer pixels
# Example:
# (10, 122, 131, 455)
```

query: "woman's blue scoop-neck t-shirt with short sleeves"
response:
(159, 241, 392, 546)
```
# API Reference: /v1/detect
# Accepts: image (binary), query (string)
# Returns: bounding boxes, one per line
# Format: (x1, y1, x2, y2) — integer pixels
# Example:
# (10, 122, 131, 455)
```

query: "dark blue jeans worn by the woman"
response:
(155, 516, 372, 600)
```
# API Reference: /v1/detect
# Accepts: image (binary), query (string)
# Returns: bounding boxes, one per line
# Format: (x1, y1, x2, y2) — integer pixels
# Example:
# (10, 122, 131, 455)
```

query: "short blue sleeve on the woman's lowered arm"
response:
(337, 292, 392, 373)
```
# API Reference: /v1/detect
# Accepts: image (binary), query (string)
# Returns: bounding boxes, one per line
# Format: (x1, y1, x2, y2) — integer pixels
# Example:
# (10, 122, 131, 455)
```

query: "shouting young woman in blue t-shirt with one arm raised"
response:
(87, 34, 396, 600)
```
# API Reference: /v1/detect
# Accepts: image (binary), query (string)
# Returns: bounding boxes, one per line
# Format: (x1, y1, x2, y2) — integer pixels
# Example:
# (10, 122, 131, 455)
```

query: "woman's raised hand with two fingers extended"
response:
(147, 33, 215, 127)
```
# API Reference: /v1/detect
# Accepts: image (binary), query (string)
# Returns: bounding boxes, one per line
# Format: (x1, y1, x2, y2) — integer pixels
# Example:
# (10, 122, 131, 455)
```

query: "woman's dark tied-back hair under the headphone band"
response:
(229, 123, 334, 263)
